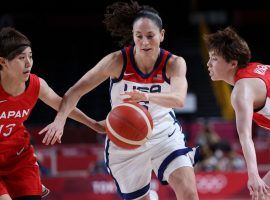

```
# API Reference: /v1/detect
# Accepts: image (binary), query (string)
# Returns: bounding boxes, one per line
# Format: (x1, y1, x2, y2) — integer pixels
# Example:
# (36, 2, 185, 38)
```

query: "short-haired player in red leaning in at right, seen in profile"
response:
(204, 27, 270, 199)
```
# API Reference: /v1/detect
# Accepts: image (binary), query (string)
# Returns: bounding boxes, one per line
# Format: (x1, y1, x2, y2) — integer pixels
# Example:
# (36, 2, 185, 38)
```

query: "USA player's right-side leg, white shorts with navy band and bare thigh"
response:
(153, 126, 199, 200)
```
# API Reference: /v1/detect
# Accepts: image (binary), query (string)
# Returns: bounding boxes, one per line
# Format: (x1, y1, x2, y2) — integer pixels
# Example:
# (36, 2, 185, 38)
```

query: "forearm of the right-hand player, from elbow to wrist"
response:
(240, 136, 259, 176)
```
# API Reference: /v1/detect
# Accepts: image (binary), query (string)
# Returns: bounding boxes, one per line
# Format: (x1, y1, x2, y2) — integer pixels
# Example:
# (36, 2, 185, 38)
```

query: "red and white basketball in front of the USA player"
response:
(106, 103, 153, 149)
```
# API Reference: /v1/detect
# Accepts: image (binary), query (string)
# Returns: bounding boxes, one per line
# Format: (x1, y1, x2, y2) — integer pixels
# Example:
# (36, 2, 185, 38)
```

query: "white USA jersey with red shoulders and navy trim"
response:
(110, 46, 179, 138)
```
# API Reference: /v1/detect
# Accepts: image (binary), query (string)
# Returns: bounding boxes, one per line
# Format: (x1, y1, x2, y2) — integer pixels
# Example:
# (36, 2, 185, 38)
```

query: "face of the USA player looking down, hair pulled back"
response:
(133, 18, 164, 56)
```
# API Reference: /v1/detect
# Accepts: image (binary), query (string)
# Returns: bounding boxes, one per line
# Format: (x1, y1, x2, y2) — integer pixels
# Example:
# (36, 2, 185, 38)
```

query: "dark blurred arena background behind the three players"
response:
(0, 0, 270, 200)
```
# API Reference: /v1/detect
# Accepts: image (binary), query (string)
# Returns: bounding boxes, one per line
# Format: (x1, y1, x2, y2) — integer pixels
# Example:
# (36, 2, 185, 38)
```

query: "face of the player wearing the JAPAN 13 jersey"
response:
(6, 47, 33, 81)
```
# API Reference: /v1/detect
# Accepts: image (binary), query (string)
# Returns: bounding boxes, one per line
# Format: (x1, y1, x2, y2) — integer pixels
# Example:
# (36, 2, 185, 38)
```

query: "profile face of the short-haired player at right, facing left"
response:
(207, 51, 229, 81)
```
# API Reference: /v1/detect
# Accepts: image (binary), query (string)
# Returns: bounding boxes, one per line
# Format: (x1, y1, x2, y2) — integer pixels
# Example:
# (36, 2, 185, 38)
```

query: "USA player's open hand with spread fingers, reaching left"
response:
(38, 121, 65, 145)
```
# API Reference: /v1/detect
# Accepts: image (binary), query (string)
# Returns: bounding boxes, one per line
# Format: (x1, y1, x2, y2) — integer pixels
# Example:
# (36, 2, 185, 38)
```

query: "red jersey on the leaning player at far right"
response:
(235, 63, 270, 130)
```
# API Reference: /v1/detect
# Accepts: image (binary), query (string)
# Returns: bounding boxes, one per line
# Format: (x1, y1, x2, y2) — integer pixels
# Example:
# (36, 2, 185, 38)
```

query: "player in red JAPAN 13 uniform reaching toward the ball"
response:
(0, 27, 103, 200)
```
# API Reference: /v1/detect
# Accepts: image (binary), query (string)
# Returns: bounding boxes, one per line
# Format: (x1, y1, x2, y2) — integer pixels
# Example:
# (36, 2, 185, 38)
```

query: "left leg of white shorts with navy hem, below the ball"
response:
(105, 140, 152, 200)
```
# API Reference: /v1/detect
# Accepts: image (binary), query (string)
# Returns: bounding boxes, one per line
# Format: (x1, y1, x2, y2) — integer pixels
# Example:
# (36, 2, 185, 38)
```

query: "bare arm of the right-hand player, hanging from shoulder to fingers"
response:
(231, 79, 270, 199)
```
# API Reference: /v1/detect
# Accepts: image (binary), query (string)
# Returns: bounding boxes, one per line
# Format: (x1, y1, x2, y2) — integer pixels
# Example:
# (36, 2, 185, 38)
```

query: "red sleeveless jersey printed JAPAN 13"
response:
(0, 74, 40, 153)
